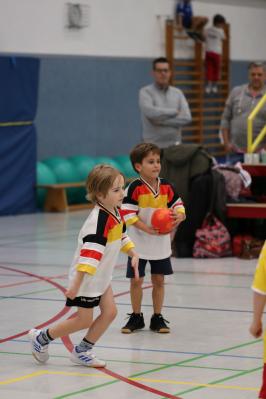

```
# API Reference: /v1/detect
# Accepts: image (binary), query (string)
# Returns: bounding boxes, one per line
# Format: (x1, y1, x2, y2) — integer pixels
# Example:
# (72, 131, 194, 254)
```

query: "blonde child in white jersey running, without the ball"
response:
(29, 165, 138, 367)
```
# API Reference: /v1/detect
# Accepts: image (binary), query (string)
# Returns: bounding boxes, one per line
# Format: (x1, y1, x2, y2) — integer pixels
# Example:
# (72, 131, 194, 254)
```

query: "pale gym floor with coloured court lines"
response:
(0, 211, 263, 399)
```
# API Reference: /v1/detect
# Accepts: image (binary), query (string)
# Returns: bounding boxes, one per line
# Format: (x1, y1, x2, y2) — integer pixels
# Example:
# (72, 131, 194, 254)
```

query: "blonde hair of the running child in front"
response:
(86, 164, 124, 203)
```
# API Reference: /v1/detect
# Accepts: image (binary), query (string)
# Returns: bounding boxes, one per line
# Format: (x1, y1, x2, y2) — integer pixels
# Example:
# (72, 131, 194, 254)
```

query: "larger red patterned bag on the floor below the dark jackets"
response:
(193, 213, 232, 258)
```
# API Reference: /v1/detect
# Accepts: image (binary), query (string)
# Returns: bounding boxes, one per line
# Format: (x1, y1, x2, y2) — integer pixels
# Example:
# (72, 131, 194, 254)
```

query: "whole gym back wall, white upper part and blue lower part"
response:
(0, 0, 266, 159)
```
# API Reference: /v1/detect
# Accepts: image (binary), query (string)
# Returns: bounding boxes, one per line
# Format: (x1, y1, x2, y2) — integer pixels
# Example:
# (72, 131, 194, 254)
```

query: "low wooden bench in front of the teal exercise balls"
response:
(37, 182, 92, 212)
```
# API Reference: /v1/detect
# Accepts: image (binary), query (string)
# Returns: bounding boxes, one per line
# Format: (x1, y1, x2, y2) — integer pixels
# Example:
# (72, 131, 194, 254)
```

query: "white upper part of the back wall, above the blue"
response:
(0, 0, 266, 60)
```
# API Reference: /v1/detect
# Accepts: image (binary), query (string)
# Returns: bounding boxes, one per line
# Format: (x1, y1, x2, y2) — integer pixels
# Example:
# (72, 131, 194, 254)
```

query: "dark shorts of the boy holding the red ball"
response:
(126, 257, 173, 278)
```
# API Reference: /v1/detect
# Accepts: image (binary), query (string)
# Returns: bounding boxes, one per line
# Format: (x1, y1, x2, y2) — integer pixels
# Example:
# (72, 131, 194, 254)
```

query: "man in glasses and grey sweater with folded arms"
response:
(139, 57, 191, 148)
